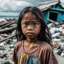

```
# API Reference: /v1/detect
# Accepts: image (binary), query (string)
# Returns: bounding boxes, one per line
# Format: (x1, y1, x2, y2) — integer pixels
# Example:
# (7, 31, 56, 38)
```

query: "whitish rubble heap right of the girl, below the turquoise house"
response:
(47, 20, 64, 56)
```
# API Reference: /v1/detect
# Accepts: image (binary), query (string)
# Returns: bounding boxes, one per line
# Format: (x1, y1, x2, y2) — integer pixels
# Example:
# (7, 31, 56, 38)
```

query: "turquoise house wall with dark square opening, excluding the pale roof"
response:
(42, 3, 64, 22)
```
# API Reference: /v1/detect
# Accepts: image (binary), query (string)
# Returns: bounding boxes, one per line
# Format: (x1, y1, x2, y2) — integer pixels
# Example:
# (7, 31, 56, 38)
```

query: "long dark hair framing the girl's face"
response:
(16, 6, 52, 44)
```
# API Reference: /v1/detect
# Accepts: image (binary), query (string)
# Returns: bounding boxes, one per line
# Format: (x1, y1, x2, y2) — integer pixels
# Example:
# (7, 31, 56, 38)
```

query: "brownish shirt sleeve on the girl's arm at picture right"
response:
(41, 48, 58, 64)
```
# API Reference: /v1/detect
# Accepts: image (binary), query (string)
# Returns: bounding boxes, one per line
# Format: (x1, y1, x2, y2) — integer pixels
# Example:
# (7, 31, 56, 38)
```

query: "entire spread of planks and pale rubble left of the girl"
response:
(0, 18, 17, 64)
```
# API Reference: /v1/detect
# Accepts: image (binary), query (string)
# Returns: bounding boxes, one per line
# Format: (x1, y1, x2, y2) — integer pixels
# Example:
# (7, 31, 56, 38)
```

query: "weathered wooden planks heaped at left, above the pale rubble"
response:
(0, 19, 17, 42)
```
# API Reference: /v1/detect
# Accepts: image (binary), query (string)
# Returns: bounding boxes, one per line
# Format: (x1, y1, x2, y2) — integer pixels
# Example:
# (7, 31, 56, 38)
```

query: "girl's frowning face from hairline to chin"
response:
(21, 12, 41, 38)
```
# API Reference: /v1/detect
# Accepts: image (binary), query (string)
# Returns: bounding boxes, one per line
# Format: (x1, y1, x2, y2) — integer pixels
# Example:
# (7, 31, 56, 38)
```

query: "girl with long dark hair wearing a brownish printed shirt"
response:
(12, 7, 57, 64)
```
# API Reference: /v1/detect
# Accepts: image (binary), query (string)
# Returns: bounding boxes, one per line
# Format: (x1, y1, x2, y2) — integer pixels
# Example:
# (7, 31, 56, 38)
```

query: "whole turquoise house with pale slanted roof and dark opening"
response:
(38, 0, 64, 22)
